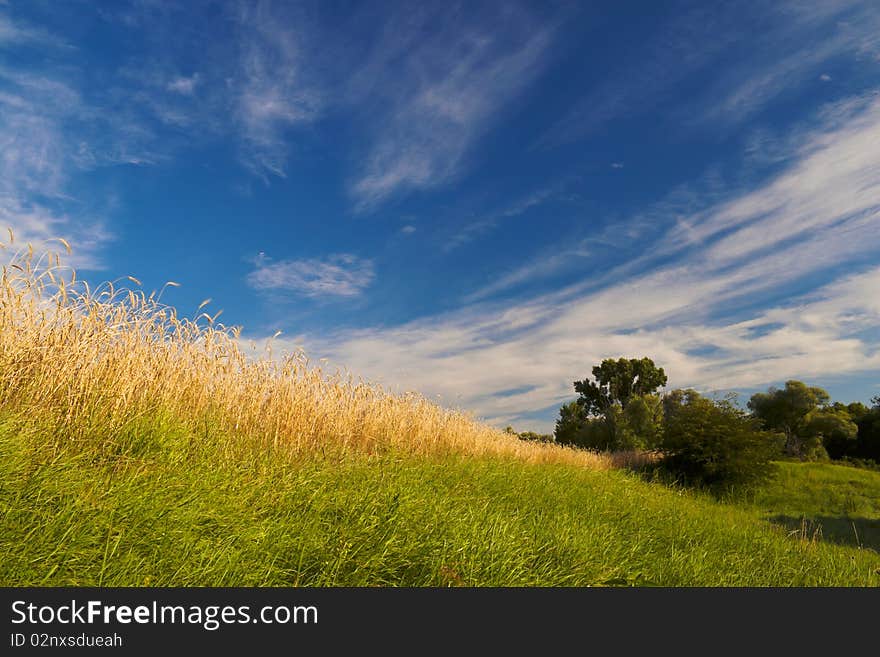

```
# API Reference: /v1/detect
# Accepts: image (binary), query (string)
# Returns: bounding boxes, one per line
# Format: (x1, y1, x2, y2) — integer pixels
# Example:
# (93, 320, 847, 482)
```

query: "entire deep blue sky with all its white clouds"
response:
(0, 0, 880, 430)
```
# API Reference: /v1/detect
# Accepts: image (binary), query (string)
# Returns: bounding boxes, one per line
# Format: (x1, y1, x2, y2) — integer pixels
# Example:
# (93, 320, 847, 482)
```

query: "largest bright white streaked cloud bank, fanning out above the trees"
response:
(272, 92, 880, 430)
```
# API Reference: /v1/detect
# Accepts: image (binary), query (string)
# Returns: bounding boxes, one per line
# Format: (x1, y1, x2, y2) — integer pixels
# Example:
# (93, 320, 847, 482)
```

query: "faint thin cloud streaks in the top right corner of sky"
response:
(537, 0, 880, 148)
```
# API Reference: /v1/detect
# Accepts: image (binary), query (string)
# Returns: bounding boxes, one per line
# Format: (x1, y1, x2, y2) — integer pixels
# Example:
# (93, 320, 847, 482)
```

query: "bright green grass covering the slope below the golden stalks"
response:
(0, 421, 880, 586)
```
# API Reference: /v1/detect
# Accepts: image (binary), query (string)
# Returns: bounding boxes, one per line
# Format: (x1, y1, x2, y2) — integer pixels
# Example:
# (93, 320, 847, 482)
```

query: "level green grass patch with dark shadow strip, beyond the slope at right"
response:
(753, 462, 880, 553)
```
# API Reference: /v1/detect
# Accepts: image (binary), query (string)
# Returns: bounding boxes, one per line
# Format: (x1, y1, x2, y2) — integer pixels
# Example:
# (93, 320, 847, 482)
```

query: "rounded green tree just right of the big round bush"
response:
(748, 380, 830, 457)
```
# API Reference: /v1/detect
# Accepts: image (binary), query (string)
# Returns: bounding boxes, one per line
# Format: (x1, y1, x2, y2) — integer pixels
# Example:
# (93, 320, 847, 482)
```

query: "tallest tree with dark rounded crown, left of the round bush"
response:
(574, 358, 666, 449)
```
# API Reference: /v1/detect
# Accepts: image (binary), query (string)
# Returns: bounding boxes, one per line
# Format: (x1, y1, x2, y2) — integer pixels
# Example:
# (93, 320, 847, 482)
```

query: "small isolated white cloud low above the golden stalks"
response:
(247, 254, 376, 298)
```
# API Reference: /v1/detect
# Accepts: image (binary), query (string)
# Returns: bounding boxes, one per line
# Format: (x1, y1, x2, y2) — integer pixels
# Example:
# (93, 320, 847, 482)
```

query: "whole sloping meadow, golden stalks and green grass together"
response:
(0, 244, 880, 586)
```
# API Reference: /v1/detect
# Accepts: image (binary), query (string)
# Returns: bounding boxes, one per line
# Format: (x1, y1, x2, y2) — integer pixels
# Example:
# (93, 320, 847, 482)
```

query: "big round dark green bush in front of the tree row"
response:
(661, 391, 783, 490)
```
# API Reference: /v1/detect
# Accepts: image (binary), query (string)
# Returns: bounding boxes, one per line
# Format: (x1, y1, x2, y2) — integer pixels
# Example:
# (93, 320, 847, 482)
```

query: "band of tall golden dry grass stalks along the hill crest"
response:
(0, 238, 610, 468)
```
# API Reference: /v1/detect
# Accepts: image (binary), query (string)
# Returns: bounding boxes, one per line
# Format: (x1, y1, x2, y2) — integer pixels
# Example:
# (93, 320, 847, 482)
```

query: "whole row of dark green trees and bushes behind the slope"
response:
(508, 358, 880, 487)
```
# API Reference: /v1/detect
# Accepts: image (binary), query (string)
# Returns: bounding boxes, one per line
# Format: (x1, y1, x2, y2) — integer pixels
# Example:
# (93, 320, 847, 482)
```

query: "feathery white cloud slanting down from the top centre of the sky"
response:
(351, 6, 553, 210)
